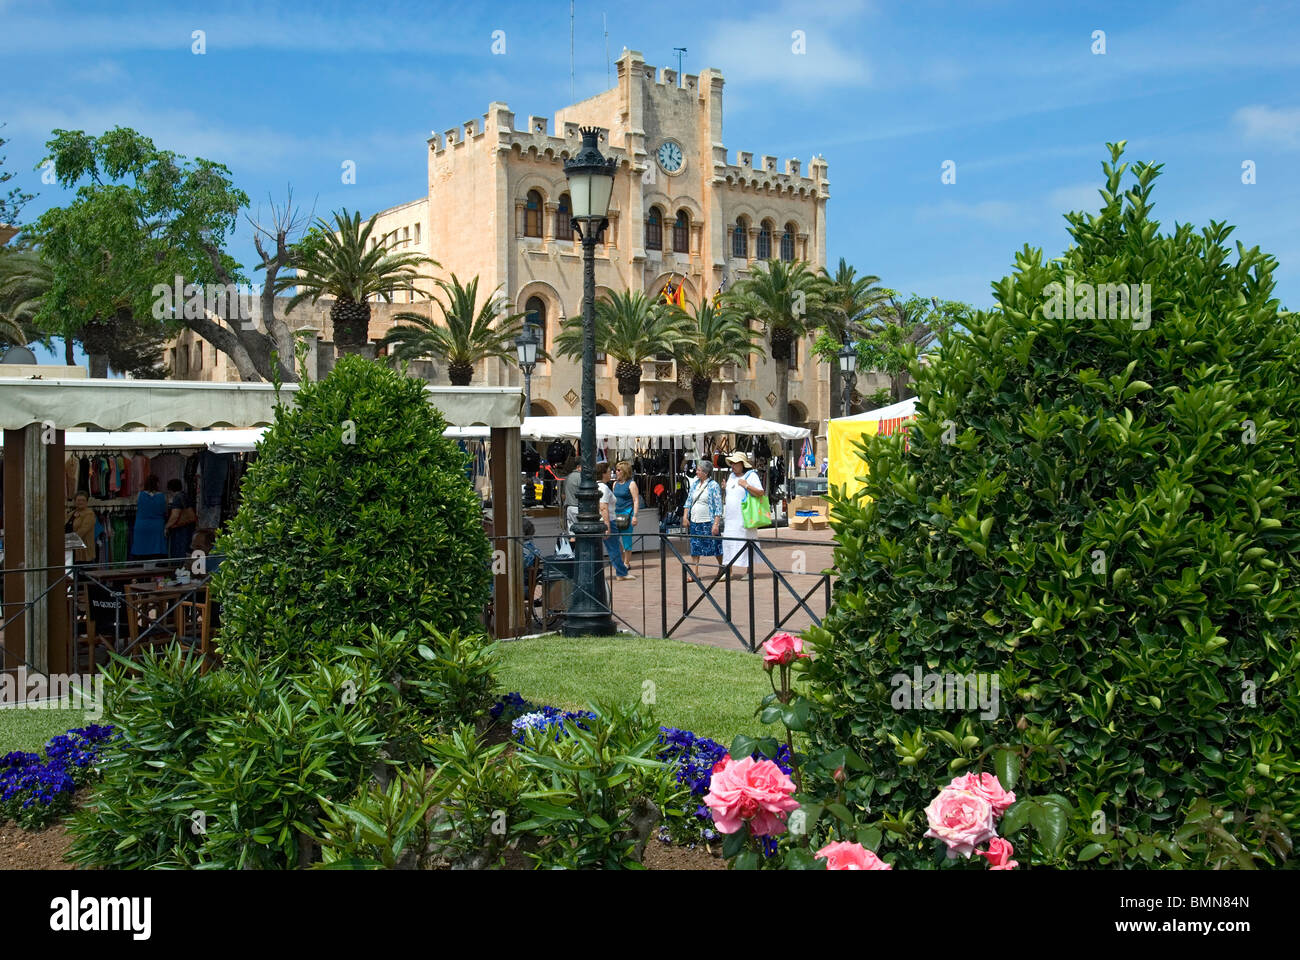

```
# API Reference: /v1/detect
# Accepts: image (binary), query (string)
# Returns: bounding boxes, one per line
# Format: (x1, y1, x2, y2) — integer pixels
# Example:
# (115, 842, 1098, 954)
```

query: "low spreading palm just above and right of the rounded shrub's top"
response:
(384, 273, 525, 386)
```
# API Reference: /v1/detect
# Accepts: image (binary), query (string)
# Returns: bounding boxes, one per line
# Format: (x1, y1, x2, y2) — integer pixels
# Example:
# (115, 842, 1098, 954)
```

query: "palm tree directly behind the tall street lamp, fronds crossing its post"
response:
(555, 290, 688, 415)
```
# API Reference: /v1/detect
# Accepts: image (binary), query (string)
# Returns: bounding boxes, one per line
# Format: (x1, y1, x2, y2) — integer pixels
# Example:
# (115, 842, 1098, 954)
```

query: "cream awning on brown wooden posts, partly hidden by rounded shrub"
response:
(0, 377, 524, 431)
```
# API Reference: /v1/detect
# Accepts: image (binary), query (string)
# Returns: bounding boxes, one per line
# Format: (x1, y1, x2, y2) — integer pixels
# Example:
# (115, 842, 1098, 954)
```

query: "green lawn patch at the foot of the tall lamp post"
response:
(498, 635, 775, 744)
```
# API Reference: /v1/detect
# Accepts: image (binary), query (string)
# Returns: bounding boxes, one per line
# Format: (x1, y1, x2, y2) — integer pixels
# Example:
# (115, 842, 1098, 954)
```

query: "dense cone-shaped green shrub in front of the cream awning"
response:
(216, 356, 491, 657)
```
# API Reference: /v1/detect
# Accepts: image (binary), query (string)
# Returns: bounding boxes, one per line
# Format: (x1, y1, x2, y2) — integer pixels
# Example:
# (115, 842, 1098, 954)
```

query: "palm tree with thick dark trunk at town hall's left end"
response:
(276, 209, 438, 345)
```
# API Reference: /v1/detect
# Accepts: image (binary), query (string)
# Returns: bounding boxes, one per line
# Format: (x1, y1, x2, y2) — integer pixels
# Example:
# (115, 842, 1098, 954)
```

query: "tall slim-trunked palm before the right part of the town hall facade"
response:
(724, 260, 826, 423)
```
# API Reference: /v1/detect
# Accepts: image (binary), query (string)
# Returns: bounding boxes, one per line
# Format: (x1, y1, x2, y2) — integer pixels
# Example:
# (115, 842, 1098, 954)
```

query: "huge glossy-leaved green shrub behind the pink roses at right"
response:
(810, 143, 1300, 866)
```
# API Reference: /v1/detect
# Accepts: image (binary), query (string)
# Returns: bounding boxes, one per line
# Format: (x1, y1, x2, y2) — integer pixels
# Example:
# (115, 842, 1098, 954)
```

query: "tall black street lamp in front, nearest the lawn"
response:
(564, 126, 618, 636)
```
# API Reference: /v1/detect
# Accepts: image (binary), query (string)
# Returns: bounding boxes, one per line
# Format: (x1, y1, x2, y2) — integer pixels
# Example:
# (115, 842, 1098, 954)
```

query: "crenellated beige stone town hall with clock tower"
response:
(169, 51, 839, 433)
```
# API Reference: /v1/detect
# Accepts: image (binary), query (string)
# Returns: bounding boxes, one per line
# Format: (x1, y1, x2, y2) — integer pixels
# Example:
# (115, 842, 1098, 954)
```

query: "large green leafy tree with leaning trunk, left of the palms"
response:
(25, 127, 312, 381)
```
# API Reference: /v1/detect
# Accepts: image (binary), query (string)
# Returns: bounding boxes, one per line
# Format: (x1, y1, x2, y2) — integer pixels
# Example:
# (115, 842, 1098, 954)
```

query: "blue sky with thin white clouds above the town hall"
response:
(0, 0, 1300, 361)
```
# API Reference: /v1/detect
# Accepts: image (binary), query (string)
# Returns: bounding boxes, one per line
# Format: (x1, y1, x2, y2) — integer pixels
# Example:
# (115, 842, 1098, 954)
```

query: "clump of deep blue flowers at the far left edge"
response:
(0, 723, 118, 830)
